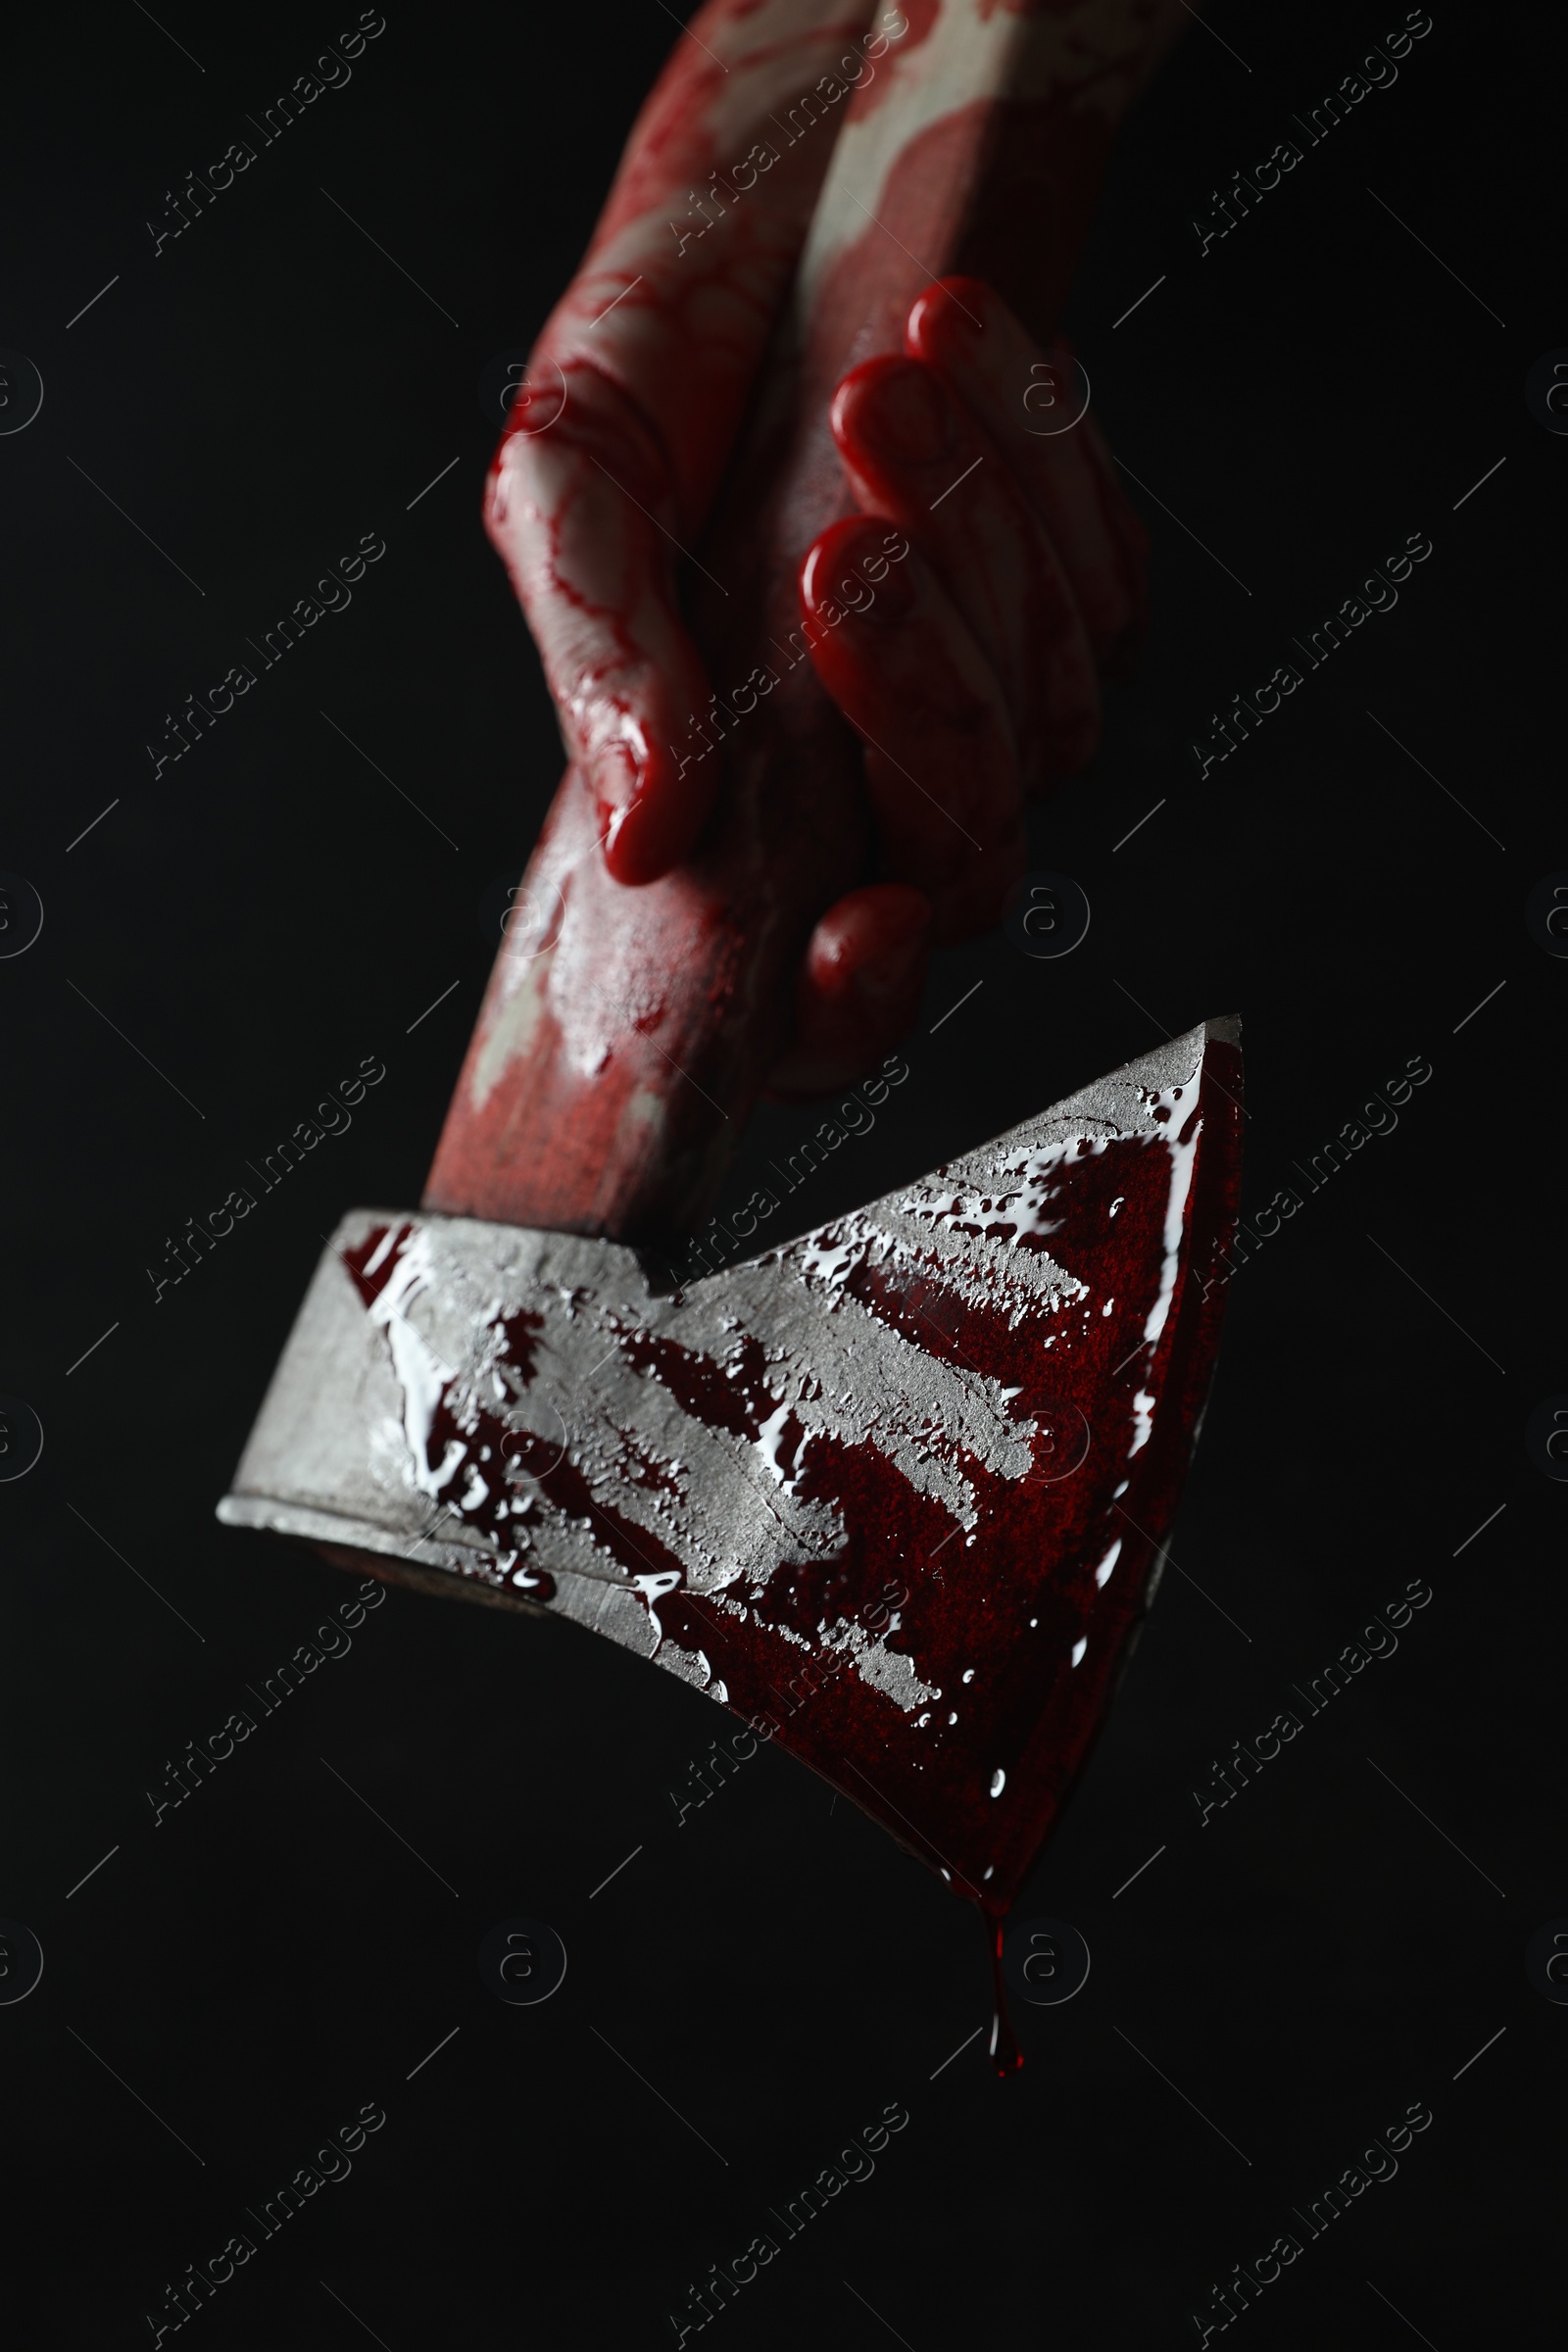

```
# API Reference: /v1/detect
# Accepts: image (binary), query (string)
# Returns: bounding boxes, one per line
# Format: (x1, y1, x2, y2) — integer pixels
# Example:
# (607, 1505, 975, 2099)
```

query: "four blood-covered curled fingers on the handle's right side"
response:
(773, 277, 1148, 1094)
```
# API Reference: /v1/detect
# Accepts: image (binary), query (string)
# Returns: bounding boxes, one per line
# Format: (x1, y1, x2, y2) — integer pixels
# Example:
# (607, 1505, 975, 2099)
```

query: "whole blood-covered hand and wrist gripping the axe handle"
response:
(487, 0, 1143, 1094)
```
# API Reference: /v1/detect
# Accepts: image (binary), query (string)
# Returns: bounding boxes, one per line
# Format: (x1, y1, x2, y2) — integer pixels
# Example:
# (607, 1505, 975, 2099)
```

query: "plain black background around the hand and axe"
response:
(0, 0, 1568, 2352)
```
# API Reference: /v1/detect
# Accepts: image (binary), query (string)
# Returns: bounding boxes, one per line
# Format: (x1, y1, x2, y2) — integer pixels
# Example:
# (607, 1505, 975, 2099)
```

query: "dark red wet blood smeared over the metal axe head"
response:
(362, 1040, 1242, 2023)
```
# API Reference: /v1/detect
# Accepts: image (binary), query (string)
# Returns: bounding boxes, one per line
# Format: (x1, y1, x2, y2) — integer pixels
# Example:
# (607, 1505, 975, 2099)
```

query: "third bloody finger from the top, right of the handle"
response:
(800, 515, 1022, 946)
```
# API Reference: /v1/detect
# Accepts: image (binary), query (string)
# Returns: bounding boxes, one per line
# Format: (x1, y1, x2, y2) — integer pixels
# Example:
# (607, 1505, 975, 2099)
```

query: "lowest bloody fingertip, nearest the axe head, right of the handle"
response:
(768, 882, 931, 1101)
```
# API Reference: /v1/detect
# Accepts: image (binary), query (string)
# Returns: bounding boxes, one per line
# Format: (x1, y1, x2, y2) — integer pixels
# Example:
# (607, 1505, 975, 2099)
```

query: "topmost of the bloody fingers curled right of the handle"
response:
(906, 277, 1148, 682)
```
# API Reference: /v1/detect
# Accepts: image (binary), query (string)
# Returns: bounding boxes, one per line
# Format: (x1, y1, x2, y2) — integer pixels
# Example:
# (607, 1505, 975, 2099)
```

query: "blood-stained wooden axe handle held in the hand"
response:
(425, 0, 1178, 1247)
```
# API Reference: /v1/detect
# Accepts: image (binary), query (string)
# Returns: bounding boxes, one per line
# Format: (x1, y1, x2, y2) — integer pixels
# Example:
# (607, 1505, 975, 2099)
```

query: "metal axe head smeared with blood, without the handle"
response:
(219, 1021, 1242, 1915)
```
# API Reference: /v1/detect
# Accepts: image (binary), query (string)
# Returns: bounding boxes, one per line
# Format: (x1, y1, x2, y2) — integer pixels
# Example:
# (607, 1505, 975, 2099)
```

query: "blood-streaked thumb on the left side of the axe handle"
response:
(484, 369, 719, 882)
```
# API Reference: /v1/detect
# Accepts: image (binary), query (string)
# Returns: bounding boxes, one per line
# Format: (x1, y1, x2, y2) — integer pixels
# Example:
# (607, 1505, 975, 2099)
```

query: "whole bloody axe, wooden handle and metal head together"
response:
(219, 0, 1242, 2050)
